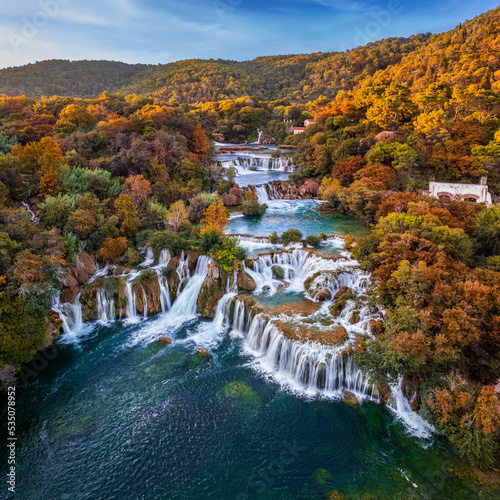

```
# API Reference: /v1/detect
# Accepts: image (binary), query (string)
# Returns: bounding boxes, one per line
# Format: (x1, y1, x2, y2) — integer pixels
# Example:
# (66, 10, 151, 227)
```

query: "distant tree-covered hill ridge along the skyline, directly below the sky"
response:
(0, 8, 500, 104)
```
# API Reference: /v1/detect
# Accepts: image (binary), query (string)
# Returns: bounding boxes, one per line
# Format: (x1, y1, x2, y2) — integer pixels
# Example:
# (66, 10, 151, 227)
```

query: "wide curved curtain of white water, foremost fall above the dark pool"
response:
(227, 299, 379, 400)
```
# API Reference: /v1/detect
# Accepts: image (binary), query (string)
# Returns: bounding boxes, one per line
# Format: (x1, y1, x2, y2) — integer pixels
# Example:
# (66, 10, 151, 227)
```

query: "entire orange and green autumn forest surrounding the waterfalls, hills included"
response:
(0, 3, 500, 472)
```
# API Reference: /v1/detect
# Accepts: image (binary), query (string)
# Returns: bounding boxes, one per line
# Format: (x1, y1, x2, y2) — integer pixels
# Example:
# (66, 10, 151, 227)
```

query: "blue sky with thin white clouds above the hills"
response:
(0, 0, 498, 68)
